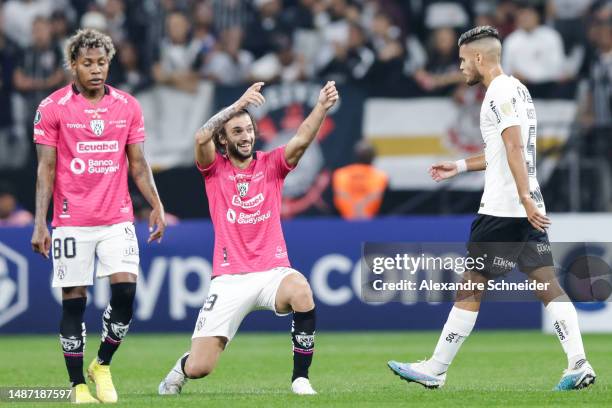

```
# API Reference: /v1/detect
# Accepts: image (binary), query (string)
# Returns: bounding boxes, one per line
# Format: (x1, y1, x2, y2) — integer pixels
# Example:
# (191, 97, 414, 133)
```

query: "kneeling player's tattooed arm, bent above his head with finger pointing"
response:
(195, 82, 266, 167)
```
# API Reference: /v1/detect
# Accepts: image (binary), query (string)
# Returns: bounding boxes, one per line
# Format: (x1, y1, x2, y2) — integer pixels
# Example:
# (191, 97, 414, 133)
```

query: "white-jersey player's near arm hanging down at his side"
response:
(502, 126, 550, 232)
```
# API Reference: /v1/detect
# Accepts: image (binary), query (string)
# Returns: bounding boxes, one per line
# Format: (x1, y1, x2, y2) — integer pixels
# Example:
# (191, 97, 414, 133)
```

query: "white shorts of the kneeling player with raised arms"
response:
(192, 267, 299, 342)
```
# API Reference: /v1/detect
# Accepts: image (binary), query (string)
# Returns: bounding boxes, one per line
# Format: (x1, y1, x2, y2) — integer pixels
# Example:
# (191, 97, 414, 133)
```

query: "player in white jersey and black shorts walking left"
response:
(388, 26, 595, 390)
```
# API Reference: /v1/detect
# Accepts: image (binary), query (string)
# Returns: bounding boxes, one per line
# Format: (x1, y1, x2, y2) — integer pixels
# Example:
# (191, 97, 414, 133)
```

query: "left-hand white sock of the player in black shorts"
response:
(426, 306, 478, 375)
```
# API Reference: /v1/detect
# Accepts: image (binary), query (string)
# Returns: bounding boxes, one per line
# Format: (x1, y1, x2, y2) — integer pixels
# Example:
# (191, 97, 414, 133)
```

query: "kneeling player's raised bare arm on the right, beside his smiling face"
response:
(285, 81, 339, 166)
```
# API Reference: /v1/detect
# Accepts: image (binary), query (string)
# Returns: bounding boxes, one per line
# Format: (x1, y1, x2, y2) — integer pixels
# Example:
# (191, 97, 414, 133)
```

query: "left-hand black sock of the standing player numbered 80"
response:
(60, 298, 87, 387)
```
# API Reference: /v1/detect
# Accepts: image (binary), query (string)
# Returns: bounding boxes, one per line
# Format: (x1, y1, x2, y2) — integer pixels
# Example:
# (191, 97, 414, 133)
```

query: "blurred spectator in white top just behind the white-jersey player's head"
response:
(502, 2, 565, 93)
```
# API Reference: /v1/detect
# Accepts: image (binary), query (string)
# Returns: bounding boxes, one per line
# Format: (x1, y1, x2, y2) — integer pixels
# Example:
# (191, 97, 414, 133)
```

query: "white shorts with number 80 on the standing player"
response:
(51, 222, 140, 288)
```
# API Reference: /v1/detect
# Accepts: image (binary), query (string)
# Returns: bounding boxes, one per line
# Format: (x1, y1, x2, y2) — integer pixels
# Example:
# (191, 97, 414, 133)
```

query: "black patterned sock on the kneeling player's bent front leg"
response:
(291, 309, 316, 382)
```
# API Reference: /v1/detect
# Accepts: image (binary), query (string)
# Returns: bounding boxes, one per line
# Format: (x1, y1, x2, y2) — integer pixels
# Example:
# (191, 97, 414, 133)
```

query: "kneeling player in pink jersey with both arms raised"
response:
(159, 82, 338, 395)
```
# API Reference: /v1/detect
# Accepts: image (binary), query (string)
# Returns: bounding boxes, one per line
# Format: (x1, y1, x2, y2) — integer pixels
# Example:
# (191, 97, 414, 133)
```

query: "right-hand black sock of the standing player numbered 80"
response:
(98, 282, 136, 365)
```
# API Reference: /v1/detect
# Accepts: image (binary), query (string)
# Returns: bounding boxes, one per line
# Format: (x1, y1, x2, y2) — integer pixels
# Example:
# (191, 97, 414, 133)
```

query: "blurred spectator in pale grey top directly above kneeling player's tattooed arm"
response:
(202, 27, 253, 85)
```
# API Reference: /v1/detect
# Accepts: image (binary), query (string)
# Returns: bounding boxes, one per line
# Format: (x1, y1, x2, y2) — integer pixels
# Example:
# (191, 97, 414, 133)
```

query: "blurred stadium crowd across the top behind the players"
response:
(0, 0, 612, 223)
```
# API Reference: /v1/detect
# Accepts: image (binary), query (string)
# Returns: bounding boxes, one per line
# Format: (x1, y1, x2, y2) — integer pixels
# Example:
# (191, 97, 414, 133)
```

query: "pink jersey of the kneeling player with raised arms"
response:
(198, 147, 293, 276)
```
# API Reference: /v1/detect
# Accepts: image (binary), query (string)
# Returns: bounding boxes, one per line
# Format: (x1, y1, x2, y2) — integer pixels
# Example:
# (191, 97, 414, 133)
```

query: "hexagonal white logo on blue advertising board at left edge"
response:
(0, 242, 28, 327)
